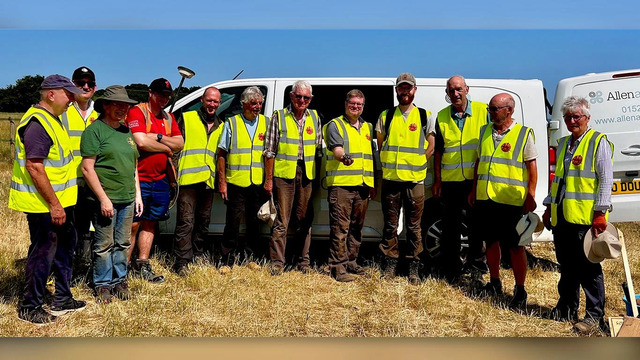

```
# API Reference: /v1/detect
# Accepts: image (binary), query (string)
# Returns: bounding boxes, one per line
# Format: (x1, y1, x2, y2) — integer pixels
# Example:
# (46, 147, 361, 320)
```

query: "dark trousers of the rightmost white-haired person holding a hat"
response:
(553, 203, 605, 322)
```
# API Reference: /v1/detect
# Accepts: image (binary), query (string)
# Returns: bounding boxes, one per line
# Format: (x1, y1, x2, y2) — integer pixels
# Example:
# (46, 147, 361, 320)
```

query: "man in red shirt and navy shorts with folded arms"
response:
(126, 78, 184, 283)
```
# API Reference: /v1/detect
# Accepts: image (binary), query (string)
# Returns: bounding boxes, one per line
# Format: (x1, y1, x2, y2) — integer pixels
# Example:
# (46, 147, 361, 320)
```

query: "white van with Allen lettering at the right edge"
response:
(549, 69, 640, 222)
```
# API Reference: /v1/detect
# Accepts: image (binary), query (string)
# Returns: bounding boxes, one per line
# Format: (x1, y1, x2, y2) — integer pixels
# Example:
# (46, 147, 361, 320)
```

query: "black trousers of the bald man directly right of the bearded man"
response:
(440, 180, 482, 275)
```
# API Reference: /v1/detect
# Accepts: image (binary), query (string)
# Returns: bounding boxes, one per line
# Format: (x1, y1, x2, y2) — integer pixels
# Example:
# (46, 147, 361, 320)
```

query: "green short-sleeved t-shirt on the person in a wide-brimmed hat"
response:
(80, 121, 139, 204)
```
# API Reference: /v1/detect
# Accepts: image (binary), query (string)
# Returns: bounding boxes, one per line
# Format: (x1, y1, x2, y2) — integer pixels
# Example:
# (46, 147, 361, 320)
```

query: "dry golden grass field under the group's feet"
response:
(0, 113, 640, 337)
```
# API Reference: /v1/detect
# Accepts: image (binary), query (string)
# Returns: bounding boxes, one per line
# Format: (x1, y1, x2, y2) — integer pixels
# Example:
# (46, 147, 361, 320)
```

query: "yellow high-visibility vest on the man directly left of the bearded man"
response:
(322, 115, 373, 187)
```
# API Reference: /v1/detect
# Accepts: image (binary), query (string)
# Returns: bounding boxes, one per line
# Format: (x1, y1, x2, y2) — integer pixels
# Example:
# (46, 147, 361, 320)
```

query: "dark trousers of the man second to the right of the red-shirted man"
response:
(222, 184, 269, 256)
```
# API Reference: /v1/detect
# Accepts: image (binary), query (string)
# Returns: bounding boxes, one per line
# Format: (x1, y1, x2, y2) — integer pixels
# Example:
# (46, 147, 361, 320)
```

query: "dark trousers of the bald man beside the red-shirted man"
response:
(173, 182, 213, 265)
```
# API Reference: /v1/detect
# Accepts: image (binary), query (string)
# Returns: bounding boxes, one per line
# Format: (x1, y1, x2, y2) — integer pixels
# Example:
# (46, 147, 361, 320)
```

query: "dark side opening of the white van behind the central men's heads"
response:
(284, 84, 395, 126)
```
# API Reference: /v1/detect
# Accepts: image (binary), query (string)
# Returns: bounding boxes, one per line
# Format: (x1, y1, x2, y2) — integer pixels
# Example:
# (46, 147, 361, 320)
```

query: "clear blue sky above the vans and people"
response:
(0, 0, 640, 103)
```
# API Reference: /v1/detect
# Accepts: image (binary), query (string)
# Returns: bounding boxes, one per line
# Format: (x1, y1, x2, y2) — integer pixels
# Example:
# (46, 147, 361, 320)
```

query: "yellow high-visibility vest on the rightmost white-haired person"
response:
(551, 129, 613, 226)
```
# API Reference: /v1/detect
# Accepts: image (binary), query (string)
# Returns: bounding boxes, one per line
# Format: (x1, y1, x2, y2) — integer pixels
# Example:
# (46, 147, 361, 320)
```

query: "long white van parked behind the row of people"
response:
(160, 77, 551, 258)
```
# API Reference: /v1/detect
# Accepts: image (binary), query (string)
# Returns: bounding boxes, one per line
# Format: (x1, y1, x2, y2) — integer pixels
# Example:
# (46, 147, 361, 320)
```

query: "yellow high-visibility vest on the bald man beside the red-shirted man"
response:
(178, 111, 222, 188)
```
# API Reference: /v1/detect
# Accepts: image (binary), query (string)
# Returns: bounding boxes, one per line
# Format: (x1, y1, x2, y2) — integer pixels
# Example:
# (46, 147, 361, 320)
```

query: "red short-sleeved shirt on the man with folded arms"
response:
(126, 106, 182, 181)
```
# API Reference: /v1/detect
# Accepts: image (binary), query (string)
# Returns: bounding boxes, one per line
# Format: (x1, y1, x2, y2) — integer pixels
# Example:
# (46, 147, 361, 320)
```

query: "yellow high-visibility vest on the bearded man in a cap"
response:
(380, 106, 431, 181)
